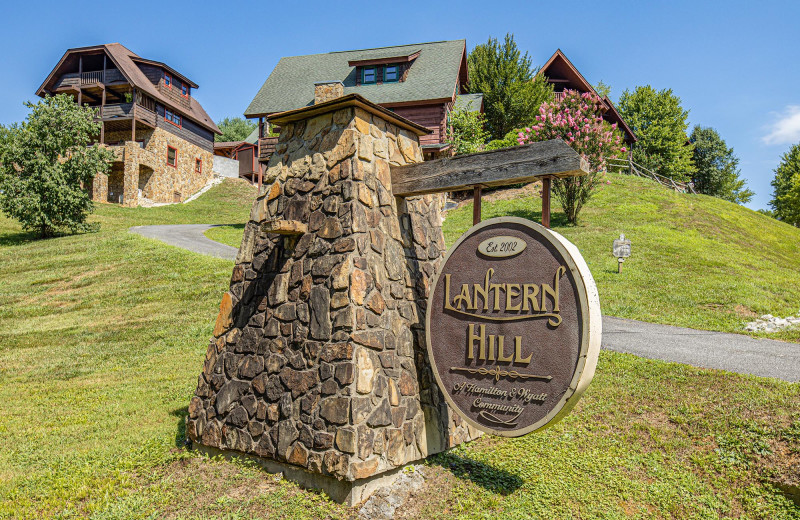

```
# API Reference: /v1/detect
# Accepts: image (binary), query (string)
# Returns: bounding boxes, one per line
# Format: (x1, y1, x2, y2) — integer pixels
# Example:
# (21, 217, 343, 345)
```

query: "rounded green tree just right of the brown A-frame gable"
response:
(619, 85, 695, 181)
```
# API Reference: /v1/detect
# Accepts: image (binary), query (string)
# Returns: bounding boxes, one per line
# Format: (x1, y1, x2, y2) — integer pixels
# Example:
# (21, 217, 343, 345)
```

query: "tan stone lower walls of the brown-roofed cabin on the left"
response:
(93, 128, 214, 206)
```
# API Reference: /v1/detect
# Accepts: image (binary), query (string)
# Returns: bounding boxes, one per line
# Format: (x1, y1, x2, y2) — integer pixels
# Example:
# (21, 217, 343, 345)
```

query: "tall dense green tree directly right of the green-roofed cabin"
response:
(467, 34, 553, 139)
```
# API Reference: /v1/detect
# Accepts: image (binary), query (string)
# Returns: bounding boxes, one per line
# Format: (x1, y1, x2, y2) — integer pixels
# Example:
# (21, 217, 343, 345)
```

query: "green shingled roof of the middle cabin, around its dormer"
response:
(244, 40, 466, 117)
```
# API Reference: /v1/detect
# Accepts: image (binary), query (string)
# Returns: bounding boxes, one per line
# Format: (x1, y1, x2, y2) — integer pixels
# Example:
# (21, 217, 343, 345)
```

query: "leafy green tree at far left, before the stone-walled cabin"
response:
(0, 94, 113, 237)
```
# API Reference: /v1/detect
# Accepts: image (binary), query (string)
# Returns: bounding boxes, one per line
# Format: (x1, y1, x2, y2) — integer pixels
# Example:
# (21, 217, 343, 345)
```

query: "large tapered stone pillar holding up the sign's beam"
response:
(187, 96, 478, 503)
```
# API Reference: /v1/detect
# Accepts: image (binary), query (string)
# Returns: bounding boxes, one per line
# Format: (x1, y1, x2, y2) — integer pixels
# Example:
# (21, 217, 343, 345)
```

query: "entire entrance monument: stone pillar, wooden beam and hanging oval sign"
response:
(186, 95, 599, 504)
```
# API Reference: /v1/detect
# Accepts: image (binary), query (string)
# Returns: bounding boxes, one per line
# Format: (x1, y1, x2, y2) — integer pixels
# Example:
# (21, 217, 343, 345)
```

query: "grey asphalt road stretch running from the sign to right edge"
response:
(602, 316, 800, 382)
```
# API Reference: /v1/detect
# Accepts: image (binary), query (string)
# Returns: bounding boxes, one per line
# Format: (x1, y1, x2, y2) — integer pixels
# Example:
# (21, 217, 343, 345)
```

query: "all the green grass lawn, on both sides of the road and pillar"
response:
(0, 177, 800, 519)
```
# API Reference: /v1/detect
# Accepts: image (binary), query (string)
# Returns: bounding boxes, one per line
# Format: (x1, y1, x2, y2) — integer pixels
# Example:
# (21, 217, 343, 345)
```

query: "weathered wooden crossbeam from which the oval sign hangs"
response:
(391, 139, 589, 197)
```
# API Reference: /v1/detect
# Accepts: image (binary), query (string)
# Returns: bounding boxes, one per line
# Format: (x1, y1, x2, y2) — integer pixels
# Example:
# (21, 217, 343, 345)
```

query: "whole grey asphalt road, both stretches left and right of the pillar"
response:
(130, 224, 800, 382)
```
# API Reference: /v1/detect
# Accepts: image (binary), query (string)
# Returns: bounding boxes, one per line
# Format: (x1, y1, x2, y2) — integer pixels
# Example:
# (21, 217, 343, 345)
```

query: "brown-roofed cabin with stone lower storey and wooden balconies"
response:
(36, 43, 221, 206)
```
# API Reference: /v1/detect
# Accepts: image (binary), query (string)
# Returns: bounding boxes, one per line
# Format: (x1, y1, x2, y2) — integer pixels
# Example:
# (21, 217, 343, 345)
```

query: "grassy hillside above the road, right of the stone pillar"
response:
(444, 175, 800, 340)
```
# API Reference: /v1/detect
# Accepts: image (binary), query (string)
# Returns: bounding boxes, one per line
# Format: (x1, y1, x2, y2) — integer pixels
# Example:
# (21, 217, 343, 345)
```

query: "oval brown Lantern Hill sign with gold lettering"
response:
(426, 217, 602, 437)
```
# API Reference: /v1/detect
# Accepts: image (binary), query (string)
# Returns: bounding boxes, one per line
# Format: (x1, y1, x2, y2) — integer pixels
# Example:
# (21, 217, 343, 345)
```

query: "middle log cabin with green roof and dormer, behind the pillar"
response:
(244, 40, 483, 171)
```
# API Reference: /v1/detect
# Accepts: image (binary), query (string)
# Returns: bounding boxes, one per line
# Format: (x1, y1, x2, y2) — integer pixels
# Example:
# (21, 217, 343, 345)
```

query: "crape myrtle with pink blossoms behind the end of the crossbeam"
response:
(517, 90, 626, 224)
